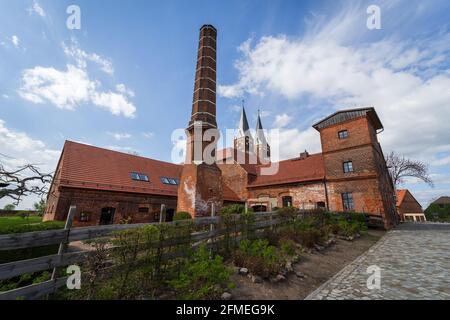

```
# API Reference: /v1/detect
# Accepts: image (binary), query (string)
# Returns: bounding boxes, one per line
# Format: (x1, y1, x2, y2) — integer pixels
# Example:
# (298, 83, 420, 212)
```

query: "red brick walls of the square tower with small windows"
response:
(320, 117, 397, 228)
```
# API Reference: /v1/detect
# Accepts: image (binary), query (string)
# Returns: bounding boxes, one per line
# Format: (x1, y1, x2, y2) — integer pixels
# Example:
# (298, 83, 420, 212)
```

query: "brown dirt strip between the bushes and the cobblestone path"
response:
(231, 230, 385, 300)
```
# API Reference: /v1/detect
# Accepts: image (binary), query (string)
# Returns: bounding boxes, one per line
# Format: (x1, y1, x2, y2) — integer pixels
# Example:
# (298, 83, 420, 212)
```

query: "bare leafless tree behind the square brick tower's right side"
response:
(386, 151, 434, 187)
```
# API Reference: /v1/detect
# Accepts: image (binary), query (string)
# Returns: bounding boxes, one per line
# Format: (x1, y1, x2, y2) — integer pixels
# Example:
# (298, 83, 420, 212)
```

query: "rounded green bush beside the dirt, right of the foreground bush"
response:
(234, 239, 283, 278)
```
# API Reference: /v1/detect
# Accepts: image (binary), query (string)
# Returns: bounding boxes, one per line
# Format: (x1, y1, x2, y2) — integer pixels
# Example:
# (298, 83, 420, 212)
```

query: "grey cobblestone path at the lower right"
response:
(306, 223, 450, 300)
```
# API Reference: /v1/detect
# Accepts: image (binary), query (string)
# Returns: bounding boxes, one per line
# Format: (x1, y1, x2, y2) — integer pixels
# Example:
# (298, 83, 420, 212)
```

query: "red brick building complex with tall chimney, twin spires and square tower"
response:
(45, 25, 398, 228)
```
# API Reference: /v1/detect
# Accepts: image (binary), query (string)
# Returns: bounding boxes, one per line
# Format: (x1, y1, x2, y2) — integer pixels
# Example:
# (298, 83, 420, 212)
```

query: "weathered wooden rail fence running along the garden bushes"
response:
(0, 206, 281, 300)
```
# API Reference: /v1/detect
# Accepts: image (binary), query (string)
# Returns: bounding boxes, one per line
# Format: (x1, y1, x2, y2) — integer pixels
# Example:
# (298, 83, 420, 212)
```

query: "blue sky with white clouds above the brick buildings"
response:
(0, 0, 450, 207)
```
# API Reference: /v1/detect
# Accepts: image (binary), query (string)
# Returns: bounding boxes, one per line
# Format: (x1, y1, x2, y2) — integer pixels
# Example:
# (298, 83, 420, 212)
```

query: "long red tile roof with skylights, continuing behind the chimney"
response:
(60, 141, 244, 201)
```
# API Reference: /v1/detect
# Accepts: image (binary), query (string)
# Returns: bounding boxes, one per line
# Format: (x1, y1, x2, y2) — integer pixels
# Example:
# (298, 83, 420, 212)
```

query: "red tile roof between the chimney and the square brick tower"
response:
(249, 153, 325, 187)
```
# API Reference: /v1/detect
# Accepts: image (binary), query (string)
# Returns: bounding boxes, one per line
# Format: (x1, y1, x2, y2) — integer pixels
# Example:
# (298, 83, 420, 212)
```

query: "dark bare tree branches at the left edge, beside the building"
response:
(0, 164, 52, 205)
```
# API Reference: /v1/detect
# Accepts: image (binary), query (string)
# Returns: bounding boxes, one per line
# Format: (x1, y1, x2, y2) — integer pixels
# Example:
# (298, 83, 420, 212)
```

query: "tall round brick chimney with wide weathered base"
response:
(177, 25, 223, 218)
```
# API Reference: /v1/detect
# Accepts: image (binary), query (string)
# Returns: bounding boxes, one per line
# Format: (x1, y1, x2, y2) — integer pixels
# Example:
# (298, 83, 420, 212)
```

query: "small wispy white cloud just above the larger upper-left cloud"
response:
(62, 39, 114, 75)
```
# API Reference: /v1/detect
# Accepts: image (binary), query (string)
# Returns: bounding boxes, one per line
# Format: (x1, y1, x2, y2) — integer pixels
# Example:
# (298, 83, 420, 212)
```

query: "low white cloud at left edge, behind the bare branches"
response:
(0, 119, 60, 208)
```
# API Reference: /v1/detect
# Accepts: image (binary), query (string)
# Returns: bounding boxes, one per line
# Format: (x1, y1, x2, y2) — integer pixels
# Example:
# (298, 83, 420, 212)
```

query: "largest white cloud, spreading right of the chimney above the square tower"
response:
(219, 3, 450, 161)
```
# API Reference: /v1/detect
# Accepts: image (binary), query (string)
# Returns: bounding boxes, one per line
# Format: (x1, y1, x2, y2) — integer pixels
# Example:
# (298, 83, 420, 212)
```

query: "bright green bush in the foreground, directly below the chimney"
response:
(168, 246, 232, 300)
